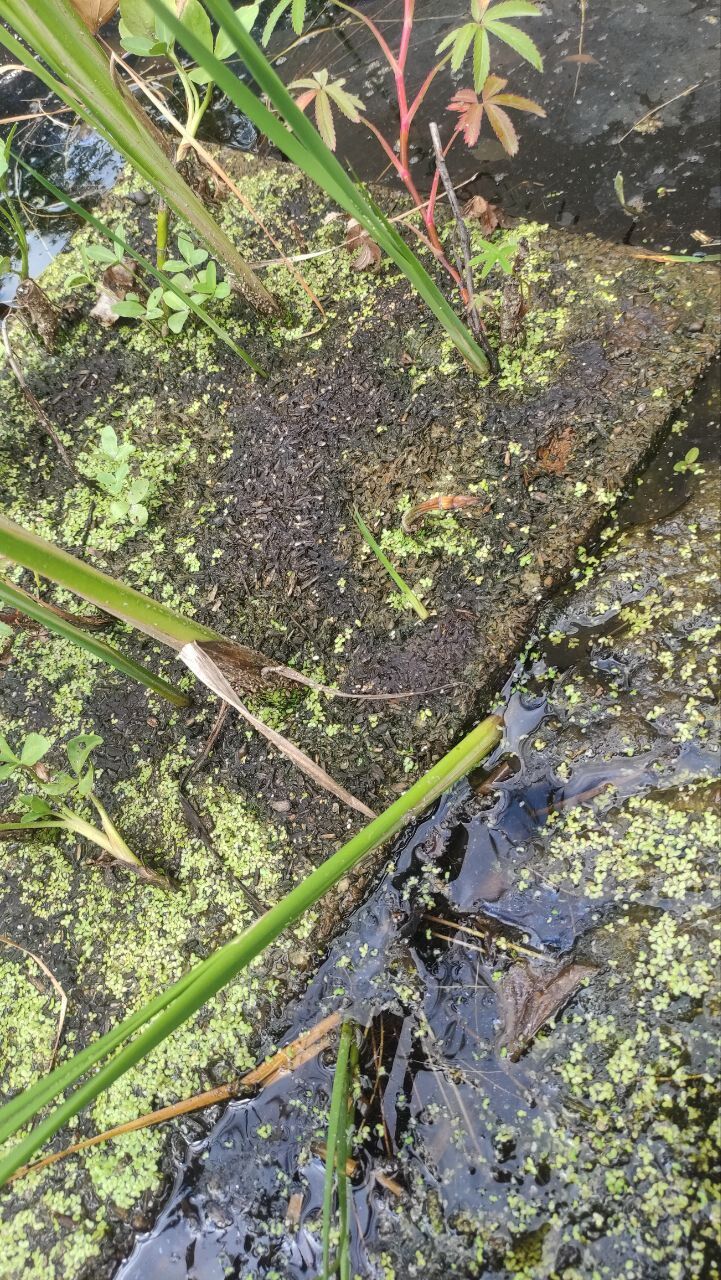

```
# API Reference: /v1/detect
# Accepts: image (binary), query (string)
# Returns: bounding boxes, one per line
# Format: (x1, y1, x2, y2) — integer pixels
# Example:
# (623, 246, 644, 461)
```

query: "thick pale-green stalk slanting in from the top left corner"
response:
(0, 0, 278, 314)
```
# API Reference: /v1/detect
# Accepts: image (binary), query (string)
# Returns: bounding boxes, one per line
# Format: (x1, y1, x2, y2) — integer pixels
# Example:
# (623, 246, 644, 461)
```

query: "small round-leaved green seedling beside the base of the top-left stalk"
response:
(113, 232, 231, 333)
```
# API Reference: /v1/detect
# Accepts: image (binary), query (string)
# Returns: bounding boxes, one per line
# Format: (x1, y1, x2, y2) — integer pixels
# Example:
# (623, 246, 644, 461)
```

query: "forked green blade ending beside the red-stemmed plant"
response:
(142, 0, 488, 375)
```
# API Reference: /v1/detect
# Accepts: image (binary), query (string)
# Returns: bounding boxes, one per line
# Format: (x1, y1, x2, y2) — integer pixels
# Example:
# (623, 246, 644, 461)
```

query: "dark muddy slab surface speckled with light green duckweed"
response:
(0, 156, 716, 1280)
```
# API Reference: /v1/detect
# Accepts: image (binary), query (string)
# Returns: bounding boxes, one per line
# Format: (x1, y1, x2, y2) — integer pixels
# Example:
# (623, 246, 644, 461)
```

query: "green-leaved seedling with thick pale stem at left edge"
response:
(0, 733, 166, 884)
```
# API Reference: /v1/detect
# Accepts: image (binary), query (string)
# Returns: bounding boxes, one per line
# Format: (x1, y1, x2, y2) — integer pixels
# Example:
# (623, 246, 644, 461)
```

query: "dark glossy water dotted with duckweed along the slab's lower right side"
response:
(118, 370, 720, 1280)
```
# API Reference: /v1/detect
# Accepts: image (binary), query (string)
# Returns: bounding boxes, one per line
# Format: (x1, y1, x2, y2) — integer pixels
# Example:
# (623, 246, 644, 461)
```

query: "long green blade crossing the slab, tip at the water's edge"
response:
(0, 716, 502, 1185)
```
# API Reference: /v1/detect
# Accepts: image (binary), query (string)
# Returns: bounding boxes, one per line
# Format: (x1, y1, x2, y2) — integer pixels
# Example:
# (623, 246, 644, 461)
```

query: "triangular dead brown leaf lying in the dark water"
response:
(498, 963, 595, 1062)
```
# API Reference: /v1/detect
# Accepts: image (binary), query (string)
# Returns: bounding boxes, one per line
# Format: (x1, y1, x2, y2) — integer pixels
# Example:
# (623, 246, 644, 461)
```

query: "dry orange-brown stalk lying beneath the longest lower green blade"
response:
(9, 1008, 341, 1181)
